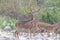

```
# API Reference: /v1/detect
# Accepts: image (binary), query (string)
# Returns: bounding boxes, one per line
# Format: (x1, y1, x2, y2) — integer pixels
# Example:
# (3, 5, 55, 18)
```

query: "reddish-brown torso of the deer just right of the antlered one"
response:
(38, 22, 53, 32)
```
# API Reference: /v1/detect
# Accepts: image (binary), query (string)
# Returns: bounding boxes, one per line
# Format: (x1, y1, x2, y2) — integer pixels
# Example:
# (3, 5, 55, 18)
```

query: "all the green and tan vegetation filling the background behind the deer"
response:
(0, 0, 60, 29)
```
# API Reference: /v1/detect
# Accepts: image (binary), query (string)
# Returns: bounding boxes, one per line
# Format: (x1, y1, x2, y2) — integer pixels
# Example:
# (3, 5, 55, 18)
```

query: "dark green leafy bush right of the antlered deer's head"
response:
(36, 7, 60, 24)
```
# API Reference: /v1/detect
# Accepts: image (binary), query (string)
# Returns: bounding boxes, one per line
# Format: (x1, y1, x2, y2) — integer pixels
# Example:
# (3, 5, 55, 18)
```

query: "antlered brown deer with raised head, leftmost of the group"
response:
(15, 9, 40, 36)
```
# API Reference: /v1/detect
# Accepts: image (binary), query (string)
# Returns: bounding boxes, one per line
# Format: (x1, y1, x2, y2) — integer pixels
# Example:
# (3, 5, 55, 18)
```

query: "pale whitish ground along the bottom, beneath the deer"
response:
(0, 30, 60, 40)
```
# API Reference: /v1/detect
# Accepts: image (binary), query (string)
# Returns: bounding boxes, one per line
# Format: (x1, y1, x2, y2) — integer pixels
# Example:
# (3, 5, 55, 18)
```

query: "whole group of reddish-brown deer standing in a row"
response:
(15, 8, 60, 36)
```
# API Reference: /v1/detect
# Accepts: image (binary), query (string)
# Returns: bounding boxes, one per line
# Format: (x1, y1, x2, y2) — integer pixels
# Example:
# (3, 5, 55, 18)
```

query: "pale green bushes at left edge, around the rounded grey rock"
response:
(0, 17, 16, 30)
